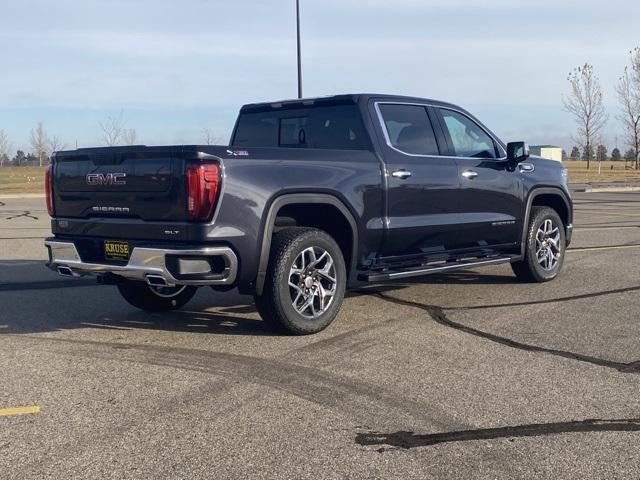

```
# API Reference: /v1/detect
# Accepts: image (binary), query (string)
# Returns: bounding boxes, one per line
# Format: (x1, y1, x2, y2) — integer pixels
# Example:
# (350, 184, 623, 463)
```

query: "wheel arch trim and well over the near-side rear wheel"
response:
(255, 193, 358, 295)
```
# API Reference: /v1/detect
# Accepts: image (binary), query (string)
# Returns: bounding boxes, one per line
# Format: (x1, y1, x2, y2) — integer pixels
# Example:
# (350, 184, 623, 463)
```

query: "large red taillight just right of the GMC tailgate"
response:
(187, 163, 220, 222)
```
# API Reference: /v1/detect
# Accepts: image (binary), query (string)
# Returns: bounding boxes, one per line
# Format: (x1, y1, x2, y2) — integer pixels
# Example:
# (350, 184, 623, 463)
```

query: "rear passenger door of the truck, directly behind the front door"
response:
(374, 102, 459, 260)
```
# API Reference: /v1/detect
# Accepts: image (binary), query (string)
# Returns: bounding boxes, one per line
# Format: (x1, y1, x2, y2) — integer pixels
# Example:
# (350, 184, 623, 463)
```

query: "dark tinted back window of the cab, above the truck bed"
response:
(232, 105, 369, 150)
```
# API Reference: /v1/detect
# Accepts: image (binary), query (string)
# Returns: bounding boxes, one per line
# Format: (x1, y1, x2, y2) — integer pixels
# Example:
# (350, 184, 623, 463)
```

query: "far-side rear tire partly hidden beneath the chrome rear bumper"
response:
(118, 281, 197, 312)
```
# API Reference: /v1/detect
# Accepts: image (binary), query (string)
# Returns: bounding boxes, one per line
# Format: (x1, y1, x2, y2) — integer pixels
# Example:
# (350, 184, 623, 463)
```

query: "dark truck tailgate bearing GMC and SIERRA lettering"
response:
(53, 147, 187, 221)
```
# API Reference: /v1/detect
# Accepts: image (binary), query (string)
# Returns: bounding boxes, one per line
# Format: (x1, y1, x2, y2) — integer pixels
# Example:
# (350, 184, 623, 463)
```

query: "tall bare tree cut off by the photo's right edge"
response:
(616, 48, 640, 170)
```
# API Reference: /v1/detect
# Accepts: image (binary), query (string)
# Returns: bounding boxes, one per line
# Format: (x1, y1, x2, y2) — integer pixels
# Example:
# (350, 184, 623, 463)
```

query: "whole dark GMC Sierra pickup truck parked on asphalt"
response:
(45, 94, 572, 334)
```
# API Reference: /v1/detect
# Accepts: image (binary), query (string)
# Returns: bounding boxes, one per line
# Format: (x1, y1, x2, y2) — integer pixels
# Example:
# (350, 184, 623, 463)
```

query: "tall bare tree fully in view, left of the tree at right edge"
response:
(562, 63, 608, 169)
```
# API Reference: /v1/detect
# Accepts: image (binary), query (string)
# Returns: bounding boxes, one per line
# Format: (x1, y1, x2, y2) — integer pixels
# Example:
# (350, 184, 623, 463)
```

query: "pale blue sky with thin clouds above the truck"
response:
(0, 0, 640, 152)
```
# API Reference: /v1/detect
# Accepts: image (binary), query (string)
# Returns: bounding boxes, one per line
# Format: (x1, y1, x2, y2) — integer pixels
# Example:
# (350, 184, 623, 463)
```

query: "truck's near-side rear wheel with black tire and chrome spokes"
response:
(254, 227, 347, 335)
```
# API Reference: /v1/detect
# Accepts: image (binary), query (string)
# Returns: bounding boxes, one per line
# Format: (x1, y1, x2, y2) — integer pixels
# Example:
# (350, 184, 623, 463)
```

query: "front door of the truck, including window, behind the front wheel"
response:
(432, 107, 522, 249)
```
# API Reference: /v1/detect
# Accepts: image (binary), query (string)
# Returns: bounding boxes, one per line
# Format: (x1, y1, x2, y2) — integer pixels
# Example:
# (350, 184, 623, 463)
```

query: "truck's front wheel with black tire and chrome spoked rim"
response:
(511, 207, 567, 283)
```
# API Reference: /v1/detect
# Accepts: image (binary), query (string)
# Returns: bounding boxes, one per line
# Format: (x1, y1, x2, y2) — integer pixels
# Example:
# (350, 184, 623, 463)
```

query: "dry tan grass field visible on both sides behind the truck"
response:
(0, 161, 640, 195)
